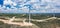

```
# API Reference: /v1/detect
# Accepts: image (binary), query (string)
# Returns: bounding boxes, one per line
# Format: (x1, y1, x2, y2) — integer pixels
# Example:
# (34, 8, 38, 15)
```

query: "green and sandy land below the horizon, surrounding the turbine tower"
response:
(0, 13, 60, 28)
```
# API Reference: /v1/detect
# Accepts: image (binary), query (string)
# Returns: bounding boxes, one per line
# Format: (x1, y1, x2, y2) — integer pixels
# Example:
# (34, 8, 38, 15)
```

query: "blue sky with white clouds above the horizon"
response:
(0, 0, 60, 13)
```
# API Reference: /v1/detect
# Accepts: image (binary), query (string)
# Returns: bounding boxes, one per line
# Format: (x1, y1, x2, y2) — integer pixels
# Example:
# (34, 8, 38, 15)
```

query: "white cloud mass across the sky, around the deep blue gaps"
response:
(0, 0, 60, 13)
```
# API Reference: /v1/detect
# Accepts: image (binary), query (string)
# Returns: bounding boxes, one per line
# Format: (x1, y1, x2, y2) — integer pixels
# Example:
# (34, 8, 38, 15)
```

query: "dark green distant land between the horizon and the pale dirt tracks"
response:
(0, 13, 60, 19)
